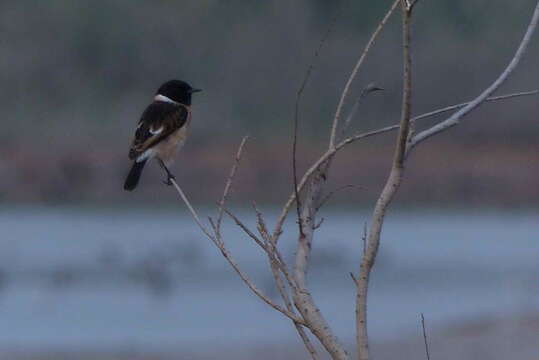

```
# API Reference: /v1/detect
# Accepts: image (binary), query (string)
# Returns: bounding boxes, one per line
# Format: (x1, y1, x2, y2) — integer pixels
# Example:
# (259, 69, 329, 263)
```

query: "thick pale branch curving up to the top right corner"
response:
(409, 2, 539, 151)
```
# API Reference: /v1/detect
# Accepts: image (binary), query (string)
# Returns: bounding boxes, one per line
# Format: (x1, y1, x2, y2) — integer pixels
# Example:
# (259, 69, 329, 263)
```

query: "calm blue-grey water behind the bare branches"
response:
(0, 208, 539, 349)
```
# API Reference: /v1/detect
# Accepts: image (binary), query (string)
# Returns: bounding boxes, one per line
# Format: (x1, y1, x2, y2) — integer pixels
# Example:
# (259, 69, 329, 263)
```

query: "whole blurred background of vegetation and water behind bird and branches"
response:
(0, 0, 539, 359)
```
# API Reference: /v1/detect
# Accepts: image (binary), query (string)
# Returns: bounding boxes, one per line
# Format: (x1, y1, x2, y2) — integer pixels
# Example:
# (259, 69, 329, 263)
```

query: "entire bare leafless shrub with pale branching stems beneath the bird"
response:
(171, 0, 539, 360)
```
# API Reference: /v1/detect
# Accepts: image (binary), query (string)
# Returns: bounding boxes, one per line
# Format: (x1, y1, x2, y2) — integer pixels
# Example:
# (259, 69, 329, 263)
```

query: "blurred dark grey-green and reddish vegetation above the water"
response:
(0, 0, 539, 207)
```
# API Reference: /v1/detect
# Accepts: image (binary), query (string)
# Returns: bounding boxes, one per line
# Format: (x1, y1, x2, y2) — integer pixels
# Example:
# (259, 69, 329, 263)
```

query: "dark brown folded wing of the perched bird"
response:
(129, 101, 189, 159)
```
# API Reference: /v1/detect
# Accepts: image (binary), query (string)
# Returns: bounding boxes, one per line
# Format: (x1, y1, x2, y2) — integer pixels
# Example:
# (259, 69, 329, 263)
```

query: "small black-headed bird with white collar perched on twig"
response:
(124, 80, 200, 191)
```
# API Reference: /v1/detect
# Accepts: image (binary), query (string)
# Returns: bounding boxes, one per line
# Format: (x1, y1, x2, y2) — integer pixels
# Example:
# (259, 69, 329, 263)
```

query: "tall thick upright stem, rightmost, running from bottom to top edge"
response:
(356, 0, 412, 360)
